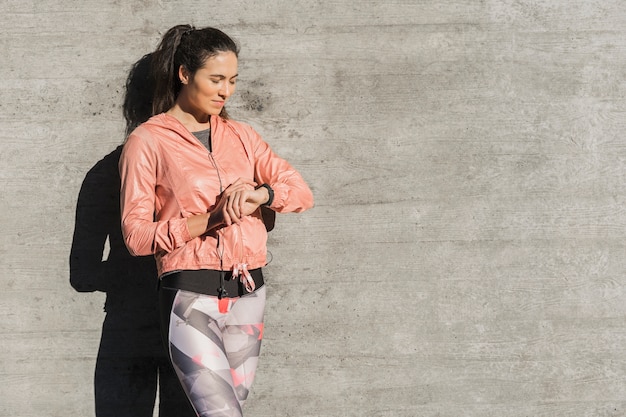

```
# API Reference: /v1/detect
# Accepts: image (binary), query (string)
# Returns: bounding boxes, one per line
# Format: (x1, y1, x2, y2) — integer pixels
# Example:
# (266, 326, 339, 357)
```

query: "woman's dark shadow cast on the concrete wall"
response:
(70, 55, 196, 417)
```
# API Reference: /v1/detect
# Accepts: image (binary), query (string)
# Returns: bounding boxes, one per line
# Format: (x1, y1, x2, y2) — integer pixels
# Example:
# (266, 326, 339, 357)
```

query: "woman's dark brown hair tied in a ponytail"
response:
(152, 25, 239, 118)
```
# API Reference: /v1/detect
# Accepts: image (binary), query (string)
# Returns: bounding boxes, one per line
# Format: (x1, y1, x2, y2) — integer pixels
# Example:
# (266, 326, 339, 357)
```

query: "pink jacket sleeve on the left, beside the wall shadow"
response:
(119, 134, 191, 256)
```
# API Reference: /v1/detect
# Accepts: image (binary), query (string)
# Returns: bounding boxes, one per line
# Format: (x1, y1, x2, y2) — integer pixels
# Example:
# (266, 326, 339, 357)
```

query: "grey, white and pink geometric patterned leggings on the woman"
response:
(160, 286, 265, 417)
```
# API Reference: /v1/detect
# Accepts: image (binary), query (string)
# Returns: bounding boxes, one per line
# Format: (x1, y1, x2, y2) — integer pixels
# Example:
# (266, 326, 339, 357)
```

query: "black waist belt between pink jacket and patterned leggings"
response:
(161, 268, 264, 298)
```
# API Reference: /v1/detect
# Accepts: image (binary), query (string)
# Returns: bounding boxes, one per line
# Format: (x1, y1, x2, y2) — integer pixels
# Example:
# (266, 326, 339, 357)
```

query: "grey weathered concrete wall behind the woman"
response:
(0, 0, 626, 417)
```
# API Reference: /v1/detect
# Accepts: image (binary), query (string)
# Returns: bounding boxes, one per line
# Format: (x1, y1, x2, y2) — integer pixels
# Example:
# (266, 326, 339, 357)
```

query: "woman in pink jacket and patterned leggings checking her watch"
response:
(120, 25, 313, 416)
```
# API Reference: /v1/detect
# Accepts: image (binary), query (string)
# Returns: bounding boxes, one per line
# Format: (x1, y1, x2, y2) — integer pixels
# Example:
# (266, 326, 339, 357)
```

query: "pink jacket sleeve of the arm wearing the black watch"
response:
(248, 127, 313, 213)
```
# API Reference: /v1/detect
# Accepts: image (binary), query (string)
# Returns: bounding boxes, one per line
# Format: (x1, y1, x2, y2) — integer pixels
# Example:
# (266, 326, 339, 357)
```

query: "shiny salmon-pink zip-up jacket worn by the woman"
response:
(120, 114, 313, 275)
